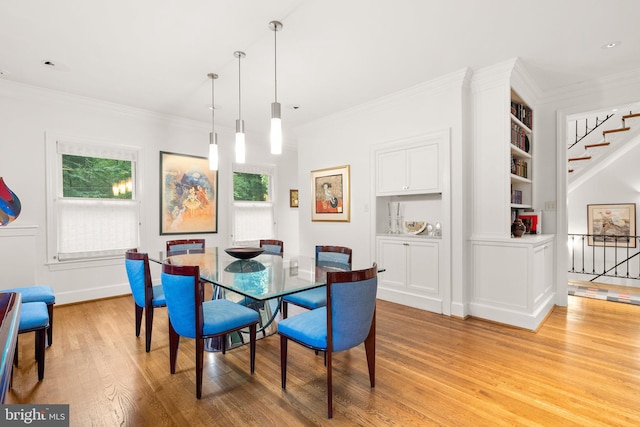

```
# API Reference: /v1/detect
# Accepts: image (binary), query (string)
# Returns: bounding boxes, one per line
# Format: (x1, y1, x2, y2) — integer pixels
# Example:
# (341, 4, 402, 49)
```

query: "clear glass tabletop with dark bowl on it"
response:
(149, 247, 349, 301)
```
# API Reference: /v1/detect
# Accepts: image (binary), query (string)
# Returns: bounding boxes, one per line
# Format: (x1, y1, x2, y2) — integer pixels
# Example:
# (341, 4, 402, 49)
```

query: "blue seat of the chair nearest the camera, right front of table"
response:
(278, 308, 327, 349)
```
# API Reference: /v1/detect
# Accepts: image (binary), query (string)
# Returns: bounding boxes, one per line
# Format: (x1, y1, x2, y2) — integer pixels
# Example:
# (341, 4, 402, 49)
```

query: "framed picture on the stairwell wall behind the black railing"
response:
(587, 203, 636, 248)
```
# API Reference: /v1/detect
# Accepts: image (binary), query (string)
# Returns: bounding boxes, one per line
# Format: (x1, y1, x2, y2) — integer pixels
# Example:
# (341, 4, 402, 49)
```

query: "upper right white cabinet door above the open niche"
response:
(406, 144, 441, 193)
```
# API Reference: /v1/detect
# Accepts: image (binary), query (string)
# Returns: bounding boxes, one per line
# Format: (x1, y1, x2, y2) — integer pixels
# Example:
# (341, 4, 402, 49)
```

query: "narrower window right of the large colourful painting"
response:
(233, 164, 275, 244)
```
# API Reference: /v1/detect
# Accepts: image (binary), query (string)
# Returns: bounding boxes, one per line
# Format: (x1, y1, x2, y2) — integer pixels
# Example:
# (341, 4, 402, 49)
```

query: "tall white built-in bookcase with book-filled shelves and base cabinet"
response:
(469, 60, 555, 330)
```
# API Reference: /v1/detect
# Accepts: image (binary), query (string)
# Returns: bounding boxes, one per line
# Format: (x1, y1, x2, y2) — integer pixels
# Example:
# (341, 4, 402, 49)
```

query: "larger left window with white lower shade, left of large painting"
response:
(47, 138, 140, 262)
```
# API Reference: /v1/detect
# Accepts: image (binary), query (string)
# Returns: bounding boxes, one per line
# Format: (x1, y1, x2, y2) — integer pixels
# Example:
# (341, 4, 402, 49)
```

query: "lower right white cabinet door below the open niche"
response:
(405, 242, 439, 295)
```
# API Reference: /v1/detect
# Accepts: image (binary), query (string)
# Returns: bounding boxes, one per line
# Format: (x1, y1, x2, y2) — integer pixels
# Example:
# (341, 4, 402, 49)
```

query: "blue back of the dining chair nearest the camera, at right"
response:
(327, 263, 378, 352)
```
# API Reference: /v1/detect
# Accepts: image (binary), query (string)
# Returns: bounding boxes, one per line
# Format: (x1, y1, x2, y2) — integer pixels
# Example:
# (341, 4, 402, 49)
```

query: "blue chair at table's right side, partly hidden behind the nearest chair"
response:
(282, 246, 352, 319)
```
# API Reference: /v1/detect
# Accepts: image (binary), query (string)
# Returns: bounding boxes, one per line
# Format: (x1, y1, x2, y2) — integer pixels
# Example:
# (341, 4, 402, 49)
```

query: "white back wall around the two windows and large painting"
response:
(0, 80, 298, 303)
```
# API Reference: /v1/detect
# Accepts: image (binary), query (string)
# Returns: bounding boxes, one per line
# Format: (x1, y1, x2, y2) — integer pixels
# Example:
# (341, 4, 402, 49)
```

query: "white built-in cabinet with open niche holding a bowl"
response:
(371, 129, 451, 314)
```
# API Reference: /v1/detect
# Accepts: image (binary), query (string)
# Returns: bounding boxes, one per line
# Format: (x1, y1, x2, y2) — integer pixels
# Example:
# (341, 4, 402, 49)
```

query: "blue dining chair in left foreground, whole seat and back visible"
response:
(162, 264, 259, 399)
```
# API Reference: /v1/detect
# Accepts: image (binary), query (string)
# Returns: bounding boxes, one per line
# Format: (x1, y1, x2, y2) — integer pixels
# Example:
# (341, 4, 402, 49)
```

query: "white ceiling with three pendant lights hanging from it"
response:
(0, 0, 640, 147)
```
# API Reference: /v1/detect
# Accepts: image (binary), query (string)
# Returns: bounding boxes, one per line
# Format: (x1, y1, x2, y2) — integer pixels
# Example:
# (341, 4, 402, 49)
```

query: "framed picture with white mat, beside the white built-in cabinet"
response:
(311, 165, 351, 222)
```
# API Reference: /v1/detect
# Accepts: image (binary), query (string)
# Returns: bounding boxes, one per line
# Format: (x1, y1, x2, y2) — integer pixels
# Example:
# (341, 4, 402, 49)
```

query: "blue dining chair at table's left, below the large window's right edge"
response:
(124, 249, 166, 353)
